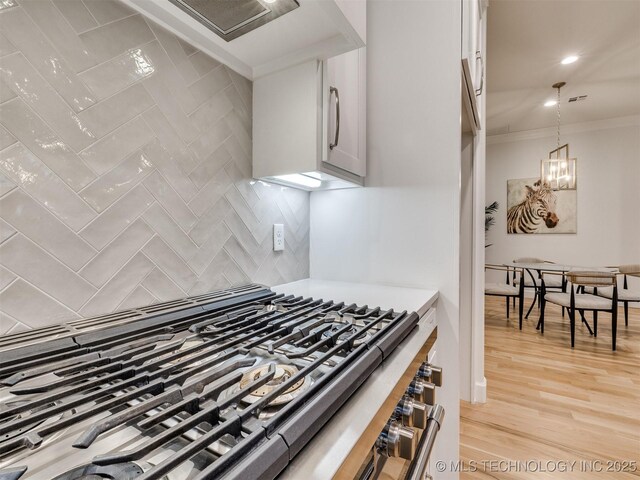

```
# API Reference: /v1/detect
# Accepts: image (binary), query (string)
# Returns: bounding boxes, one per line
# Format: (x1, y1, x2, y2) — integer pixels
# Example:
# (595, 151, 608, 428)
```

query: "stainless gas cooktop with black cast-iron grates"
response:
(0, 285, 418, 480)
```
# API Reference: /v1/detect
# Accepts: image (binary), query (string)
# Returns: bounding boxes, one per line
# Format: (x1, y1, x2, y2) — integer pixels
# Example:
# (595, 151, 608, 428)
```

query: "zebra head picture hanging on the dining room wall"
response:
(507, 178, 576, 233)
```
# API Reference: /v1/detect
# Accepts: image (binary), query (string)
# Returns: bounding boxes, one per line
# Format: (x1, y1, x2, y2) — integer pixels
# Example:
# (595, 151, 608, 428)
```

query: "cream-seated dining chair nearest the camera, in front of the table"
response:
(538, 271, 618, 351)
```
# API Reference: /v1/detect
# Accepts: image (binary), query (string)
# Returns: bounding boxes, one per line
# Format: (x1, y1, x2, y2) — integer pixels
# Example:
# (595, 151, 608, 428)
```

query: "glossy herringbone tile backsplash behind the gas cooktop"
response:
(0, 0, 309, 334)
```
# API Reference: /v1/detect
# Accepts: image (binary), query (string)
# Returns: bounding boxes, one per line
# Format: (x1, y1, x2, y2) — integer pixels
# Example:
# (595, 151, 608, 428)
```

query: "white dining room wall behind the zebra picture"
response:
(486, 117, 640, 288)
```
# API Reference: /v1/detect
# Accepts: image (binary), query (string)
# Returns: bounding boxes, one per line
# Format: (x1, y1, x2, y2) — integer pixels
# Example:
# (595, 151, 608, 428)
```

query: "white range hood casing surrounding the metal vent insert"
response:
(123, 0, 366, 80)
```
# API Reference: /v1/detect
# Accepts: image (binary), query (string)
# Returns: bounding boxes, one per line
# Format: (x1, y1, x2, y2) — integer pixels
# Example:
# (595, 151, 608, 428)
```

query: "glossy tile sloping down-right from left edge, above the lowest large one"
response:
(0, 235, 97, 310)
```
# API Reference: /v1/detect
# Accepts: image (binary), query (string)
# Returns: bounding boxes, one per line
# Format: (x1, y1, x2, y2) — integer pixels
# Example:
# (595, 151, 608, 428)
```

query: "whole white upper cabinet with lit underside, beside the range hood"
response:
(253, 48, 366, 190)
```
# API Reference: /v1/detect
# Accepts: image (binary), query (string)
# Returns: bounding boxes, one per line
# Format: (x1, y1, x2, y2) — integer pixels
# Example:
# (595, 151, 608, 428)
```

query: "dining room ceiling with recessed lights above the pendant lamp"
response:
(487, 0, 640, 135)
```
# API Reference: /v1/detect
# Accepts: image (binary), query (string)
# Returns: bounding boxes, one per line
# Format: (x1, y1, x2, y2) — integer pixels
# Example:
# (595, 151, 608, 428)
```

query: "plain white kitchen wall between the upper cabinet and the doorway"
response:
(311, 0, 461, 478)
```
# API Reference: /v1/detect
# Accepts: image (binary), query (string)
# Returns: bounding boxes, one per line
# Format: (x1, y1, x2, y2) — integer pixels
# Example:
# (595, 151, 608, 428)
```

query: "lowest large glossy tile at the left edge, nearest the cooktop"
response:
(0, 279, 80, 328)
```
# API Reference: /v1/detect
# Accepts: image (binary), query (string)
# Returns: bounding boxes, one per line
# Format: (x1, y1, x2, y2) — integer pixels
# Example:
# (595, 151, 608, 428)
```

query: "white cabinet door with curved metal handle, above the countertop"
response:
(323, 48, 366, 177)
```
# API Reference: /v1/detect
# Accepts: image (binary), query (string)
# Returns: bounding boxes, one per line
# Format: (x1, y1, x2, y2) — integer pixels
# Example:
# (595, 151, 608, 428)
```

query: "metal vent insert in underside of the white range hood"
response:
(170, 0, 300, 42)
